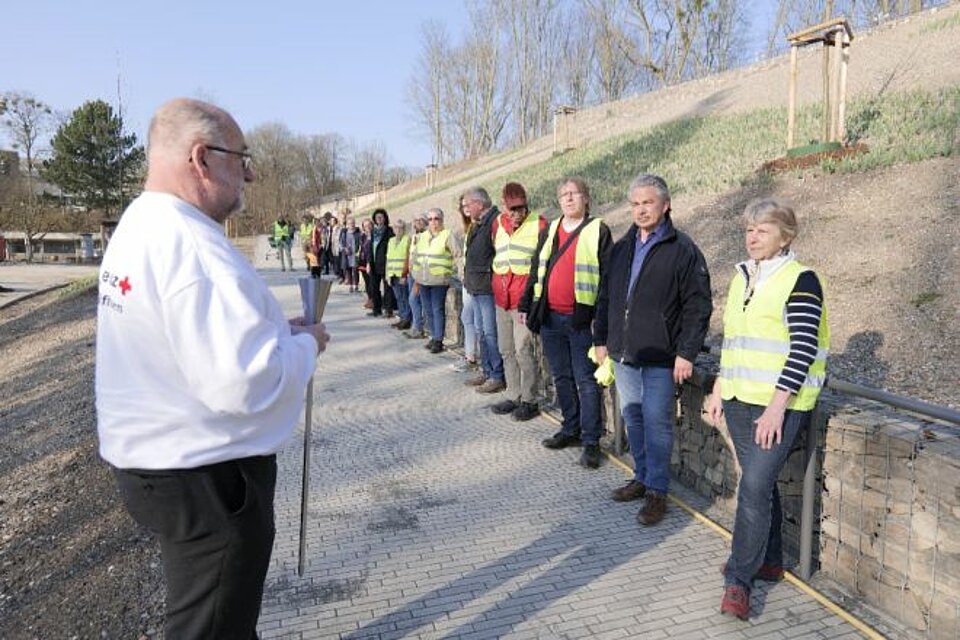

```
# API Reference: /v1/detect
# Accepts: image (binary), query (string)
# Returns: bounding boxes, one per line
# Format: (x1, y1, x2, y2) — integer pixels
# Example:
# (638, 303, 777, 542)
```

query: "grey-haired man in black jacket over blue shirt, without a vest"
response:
(594, 174, 713, 525)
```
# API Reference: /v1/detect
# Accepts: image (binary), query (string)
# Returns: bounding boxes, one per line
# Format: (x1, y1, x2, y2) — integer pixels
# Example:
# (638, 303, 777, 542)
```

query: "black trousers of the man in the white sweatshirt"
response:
(114, 455, 277, 640)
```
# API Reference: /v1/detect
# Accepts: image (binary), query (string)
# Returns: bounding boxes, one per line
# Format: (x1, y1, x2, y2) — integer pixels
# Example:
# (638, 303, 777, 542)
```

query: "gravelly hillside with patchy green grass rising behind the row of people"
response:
(376, 3, 960, 407)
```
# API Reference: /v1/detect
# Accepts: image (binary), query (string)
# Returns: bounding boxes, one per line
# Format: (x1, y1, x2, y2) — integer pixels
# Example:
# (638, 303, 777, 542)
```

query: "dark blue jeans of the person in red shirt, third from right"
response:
(540, 311, 603, 444)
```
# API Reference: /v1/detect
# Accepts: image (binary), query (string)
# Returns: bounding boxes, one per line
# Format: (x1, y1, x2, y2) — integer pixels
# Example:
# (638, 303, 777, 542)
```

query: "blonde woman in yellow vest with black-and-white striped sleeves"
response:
(707, 198, 830, 620)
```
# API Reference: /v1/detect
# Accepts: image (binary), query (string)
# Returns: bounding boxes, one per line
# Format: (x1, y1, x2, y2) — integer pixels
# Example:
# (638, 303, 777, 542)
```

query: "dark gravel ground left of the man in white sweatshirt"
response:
(0, 291, 163, 640)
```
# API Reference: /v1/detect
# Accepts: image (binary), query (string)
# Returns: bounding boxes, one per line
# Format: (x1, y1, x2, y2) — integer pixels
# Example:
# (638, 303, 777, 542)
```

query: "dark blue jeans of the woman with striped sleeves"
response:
(723, 399, 811, 588)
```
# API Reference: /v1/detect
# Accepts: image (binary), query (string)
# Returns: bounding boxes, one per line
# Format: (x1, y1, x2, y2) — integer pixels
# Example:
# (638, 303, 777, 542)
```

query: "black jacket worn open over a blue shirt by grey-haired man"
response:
(594, 215, 713, 367)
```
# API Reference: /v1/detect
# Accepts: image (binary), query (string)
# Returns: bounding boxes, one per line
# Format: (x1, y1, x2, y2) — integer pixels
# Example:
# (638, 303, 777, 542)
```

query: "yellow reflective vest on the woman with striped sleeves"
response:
(720, 261, 830, 411)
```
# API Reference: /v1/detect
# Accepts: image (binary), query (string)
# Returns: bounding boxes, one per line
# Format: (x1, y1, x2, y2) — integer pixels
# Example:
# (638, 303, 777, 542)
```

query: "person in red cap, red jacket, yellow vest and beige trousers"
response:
(490, 182, 547, 420)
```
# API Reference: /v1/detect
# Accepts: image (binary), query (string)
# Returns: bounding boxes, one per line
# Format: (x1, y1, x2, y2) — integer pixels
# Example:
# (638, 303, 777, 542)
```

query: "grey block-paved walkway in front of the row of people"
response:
(260, 270, 872, 640)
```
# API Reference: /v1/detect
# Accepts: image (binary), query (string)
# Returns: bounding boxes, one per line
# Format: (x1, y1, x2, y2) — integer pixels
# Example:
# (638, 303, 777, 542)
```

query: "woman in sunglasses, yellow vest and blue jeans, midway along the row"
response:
(411, 208, 460, 353)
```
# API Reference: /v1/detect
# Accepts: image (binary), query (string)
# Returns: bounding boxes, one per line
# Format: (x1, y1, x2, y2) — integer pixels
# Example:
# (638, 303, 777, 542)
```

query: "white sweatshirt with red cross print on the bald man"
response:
(96, 192, 317, 469)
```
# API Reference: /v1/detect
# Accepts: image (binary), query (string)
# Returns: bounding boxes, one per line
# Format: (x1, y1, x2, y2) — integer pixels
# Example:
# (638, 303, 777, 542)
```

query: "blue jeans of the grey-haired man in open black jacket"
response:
(613, 362, 676, 494)
